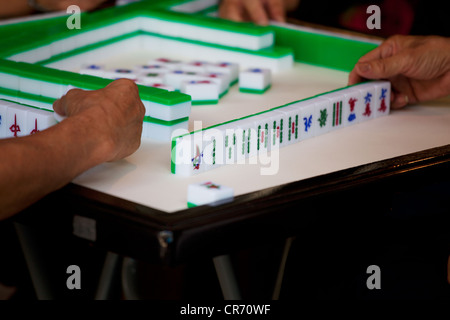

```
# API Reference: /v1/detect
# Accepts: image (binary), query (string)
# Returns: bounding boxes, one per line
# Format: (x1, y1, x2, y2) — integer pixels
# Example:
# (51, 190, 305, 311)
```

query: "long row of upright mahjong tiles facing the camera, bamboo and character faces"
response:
(171, 81, 391, 176)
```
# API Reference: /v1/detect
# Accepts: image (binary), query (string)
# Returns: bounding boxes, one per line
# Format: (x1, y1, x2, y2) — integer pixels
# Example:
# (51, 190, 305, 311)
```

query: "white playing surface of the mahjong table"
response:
(54, 51, 450, 213)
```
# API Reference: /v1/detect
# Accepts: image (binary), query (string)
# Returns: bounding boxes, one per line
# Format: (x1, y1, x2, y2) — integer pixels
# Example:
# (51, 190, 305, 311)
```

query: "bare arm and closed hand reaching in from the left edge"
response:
(0, 80, 145, 220)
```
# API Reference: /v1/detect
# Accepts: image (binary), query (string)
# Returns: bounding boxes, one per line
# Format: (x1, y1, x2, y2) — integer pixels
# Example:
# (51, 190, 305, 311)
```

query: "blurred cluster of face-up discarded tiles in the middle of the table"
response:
(80, 58, 239, 105)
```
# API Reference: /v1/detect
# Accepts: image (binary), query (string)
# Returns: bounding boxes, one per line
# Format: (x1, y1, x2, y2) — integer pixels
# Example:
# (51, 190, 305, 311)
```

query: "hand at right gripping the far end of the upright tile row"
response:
(348, 36, 450, 109)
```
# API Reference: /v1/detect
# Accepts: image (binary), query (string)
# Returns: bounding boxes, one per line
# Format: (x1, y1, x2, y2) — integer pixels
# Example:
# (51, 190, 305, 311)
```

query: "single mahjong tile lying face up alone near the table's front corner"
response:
(187, 181, 234, 206)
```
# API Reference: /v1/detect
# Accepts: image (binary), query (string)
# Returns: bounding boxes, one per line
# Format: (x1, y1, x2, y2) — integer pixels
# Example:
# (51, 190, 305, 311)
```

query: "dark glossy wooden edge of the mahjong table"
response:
(12, 145, 450, 264)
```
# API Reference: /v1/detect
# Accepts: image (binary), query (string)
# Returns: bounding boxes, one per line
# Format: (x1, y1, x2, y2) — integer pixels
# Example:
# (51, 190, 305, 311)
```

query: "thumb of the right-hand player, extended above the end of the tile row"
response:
(355, 54, 409, 79)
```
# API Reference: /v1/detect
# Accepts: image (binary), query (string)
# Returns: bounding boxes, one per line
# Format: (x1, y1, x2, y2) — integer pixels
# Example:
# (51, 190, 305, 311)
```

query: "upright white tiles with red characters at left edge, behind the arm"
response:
(0, 99, 56, 139)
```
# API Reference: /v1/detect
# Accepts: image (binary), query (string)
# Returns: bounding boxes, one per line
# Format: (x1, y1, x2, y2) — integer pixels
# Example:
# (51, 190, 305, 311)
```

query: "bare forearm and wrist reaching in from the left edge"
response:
(0, 117, 108, 220)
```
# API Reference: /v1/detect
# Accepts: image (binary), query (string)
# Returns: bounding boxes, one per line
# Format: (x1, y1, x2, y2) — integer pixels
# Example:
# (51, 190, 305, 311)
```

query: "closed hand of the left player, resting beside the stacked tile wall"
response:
(53, 79, 145, 163)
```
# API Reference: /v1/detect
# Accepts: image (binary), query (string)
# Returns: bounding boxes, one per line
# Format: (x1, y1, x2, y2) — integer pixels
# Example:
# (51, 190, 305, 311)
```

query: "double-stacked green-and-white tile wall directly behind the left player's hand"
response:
(0, 60, 191, 142)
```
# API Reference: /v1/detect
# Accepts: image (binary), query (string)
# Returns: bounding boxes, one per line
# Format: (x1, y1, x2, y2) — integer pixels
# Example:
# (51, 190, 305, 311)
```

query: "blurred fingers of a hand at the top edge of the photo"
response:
(219, 0, 299, 25)
